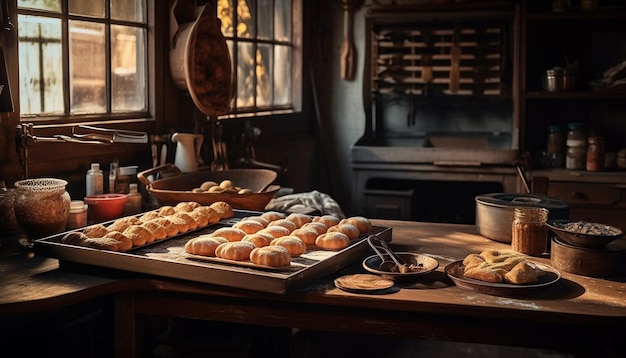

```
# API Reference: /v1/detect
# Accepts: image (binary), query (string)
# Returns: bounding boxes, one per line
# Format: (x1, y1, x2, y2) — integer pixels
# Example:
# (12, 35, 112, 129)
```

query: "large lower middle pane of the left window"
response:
(69, 21, 106, 113)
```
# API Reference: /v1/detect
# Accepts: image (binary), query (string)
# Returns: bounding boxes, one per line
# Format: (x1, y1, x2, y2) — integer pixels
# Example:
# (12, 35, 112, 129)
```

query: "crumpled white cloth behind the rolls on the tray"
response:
(265, 190, 346, 219)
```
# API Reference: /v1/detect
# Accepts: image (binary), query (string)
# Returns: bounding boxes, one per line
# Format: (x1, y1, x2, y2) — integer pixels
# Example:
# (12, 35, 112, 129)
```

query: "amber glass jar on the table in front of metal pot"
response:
(511, 207, 548, 256)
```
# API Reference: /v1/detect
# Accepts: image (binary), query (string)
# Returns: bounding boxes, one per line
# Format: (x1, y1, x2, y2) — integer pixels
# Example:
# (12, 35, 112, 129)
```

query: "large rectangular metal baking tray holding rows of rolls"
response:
(34, 210, 391, 294)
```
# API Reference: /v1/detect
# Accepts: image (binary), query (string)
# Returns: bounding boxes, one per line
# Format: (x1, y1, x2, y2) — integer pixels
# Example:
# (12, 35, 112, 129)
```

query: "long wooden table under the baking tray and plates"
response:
(0, 220, 626, 356)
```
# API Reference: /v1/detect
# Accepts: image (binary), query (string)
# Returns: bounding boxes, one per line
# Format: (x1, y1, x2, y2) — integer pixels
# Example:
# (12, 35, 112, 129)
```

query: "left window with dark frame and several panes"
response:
(17, 0, 148, 121)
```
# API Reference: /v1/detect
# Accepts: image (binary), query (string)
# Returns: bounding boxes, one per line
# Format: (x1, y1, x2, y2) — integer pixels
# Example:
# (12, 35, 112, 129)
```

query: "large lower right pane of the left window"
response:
(111, 25, 147, 112)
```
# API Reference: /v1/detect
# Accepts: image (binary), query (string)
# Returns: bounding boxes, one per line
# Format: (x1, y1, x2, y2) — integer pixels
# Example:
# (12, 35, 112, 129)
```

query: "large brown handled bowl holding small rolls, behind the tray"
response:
(137, 164, 280, 211)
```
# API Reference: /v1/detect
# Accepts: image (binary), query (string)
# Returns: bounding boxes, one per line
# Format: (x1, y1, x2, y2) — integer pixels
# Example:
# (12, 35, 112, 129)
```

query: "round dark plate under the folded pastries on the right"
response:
(444, 260, 561, 295)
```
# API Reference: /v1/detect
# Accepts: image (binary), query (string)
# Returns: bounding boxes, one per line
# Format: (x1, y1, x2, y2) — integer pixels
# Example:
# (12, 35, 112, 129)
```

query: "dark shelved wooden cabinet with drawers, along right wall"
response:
(518, 0, 626, 228)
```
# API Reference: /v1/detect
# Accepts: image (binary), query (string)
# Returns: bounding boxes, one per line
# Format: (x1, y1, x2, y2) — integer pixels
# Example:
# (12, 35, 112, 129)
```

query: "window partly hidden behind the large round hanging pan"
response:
(217, 0, 301, 114)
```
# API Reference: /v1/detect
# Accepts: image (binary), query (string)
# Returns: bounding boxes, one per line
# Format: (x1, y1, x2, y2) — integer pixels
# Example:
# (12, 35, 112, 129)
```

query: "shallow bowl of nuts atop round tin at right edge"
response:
(547, 220, 624, 249)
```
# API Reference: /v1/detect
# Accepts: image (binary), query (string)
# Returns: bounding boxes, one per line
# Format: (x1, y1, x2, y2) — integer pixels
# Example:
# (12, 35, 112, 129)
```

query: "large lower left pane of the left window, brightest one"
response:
(18, 15, 64, 114)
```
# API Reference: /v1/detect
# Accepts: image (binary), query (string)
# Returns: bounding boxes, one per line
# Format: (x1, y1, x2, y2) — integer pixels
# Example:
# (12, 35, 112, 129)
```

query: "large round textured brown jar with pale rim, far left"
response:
(13, 178, 70, 247)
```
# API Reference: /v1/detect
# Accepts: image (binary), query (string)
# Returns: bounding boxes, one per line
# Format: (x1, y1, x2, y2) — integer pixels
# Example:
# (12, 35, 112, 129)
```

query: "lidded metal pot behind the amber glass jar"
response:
(476, 193, 569, 243)
